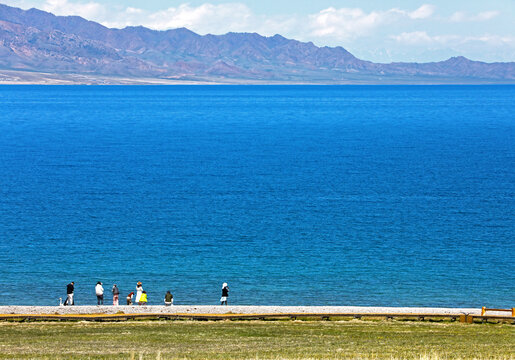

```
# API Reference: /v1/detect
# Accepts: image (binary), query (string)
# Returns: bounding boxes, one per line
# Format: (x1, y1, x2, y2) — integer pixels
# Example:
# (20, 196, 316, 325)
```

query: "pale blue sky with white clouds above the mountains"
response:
(0, 0, 515, 62)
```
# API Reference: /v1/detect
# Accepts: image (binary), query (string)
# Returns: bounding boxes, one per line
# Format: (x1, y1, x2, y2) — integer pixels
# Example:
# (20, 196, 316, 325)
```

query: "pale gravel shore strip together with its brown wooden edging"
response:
(0, 305, 515, 323)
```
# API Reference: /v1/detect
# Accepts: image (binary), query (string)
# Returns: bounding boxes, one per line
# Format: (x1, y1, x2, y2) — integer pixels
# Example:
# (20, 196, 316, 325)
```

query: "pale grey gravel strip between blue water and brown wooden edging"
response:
(0, 305, 490, 315)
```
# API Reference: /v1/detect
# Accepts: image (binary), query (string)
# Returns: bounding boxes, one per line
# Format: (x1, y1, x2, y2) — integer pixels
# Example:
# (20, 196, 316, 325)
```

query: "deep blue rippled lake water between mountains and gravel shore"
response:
(0, 86, 515, 307)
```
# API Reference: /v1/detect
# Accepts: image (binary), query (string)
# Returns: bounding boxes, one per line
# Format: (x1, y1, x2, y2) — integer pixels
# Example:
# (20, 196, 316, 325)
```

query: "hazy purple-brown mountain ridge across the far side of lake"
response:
(0, 4, 515, 83)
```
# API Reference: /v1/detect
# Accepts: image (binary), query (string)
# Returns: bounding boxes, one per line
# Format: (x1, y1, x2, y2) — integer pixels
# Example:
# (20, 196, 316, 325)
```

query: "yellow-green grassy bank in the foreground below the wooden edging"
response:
(0, 321, 515, 360)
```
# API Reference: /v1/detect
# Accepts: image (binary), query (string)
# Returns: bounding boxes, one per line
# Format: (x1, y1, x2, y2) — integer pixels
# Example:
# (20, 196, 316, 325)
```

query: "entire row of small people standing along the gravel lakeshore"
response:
(63, 281, 229, 306)
